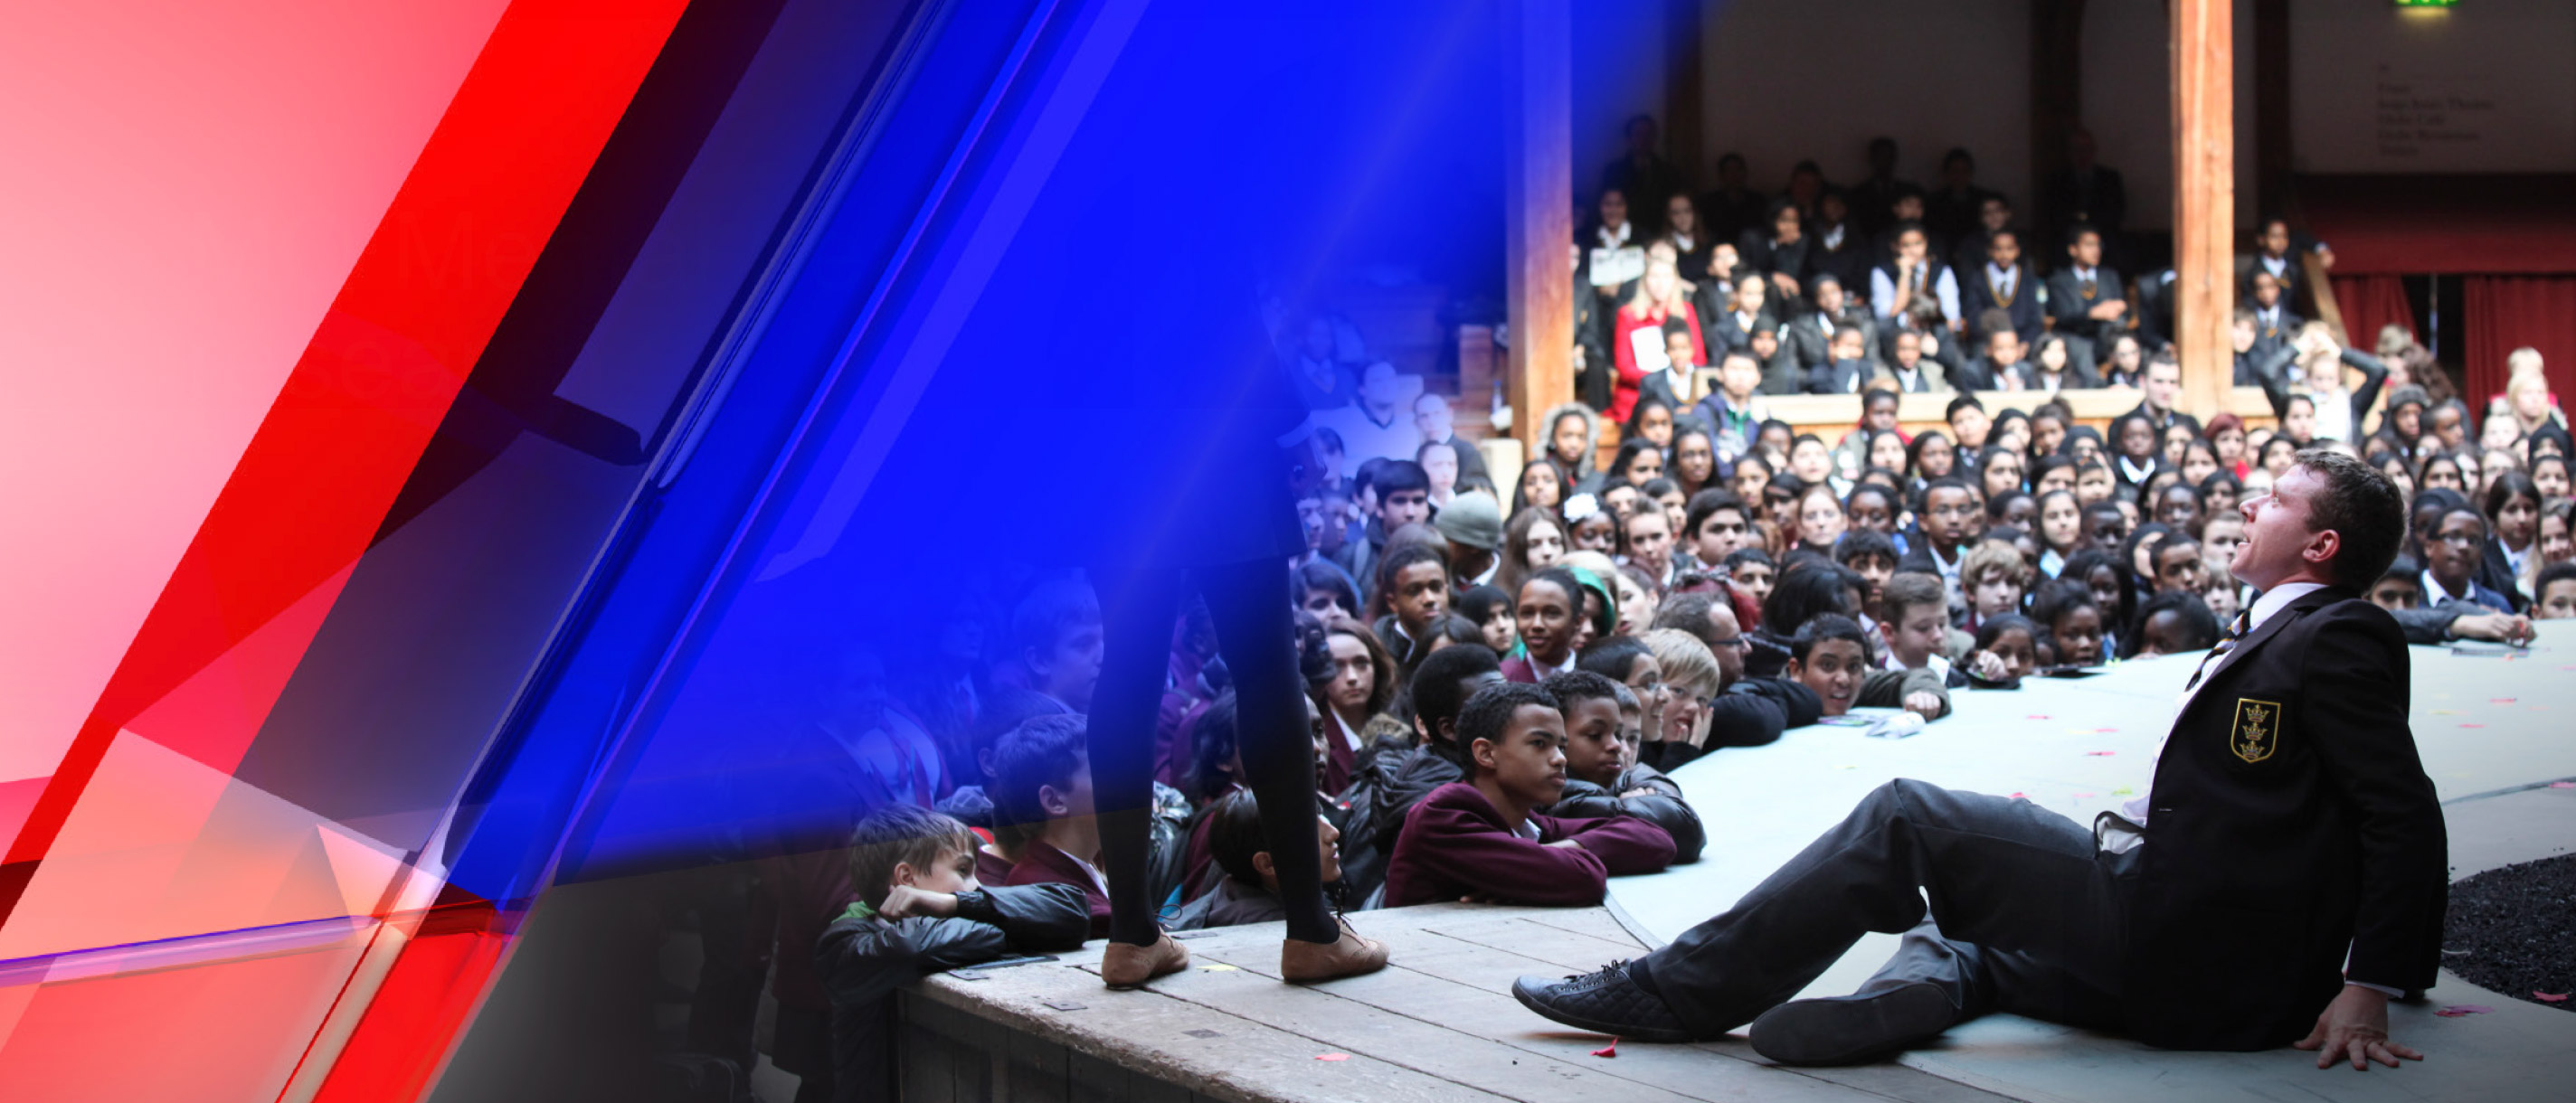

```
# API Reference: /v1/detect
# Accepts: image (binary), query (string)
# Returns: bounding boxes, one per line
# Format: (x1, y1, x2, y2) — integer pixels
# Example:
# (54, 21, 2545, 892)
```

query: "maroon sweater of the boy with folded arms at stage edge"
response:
(1386, 781, 1672, 907)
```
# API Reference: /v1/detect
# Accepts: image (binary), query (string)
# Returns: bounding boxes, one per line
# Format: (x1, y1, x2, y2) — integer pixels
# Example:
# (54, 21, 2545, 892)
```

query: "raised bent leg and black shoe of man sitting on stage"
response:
(1515, 781, 2126, 1042)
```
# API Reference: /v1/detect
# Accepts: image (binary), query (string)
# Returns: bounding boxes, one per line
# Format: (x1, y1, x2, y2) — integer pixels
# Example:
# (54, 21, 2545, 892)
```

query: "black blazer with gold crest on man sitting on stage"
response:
(2123, 588, 2449, 1049)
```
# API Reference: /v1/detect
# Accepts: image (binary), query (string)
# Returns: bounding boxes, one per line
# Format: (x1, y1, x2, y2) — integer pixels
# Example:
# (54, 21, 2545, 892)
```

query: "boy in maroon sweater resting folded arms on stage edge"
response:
(1386, 683, 1672, 907)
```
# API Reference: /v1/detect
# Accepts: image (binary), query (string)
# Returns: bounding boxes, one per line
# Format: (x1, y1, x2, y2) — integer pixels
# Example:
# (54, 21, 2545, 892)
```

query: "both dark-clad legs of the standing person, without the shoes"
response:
(1090, 560, 1340, 946)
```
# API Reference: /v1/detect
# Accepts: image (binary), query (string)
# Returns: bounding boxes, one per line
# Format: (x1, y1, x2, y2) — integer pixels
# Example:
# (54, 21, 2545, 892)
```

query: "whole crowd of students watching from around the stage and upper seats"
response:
(781, 123, 2576, 1098)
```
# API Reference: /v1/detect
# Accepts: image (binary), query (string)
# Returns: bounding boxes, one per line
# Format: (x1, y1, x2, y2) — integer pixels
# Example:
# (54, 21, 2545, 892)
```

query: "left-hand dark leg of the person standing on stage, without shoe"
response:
(1087, 567, 1179, 946)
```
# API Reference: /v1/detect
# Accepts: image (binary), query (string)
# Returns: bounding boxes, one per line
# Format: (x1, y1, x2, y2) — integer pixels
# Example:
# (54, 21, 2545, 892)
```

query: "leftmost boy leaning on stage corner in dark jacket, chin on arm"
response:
(814, 804, 1093, 1103)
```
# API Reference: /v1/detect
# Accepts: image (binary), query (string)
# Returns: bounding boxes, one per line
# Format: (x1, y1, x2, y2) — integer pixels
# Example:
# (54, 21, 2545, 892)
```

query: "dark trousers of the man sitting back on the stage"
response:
(1638, 781, 2138, 1033)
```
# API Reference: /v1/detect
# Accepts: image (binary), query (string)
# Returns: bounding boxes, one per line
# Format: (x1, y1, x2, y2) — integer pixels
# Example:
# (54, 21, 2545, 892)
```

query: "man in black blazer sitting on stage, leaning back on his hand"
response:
(1512, 451, 2448, 1070)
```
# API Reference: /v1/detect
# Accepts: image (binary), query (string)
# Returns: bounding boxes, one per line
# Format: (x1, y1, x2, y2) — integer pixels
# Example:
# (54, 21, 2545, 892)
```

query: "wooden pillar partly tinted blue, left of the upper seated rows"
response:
(1501, 0, 1574, 457)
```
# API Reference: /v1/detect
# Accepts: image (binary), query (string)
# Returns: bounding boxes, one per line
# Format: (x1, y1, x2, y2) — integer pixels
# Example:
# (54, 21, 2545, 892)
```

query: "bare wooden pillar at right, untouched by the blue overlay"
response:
(2172, 0, 2236, 420)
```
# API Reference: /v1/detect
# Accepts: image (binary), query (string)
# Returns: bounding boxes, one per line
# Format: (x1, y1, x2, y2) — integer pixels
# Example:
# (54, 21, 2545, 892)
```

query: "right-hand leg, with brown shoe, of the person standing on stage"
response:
(1195, 560, 1386, 982)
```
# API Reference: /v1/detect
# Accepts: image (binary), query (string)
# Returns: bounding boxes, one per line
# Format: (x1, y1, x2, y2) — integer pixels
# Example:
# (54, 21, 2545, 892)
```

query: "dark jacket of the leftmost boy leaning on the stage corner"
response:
(814, 884, 1090, 1103)
